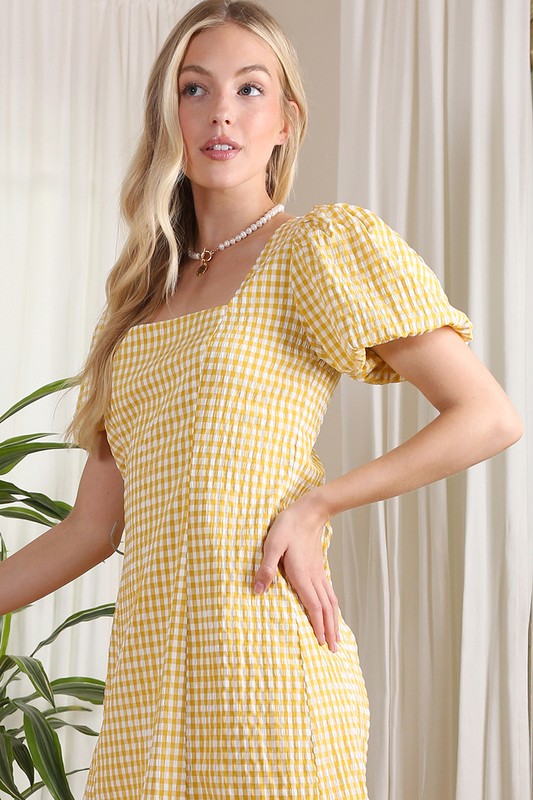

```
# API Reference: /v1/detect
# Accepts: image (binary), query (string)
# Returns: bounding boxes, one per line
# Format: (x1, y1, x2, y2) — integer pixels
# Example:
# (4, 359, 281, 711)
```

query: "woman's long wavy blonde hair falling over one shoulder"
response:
(67, 0, 307, 452)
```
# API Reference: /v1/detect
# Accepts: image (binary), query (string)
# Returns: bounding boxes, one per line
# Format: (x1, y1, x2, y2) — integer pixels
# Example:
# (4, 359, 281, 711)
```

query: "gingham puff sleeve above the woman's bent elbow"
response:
(290, 204, 472, 383)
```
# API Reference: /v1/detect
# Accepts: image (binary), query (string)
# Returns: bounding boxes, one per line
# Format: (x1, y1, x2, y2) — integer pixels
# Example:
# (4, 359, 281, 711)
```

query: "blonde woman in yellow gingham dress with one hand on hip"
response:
(0, 0, 520, 800)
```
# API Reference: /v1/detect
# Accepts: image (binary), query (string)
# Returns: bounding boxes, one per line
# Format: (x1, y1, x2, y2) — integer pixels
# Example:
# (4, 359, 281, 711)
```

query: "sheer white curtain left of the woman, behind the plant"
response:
(0, 0, 194, 798)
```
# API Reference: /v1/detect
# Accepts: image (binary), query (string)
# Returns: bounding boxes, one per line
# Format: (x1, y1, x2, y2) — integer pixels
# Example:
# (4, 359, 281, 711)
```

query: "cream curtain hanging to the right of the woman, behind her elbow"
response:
(335, 0, 533, 800)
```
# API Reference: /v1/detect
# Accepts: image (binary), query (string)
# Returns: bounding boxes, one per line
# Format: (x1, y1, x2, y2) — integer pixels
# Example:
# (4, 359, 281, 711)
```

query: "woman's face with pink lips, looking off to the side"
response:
(179, 23, 288, 198)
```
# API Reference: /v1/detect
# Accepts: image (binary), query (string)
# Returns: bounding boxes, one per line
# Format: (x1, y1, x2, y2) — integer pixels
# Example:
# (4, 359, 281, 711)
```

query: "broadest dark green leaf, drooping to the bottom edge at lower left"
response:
(13, 700, 75, 800)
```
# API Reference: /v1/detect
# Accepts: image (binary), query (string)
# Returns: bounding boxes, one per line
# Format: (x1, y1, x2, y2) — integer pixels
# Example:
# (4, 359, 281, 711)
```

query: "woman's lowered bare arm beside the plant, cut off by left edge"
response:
(0, 433, 124, 615)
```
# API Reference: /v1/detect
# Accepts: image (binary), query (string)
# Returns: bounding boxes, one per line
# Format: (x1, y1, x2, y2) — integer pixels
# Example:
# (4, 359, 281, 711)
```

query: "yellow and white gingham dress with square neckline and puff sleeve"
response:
(81, 205, 470, 800)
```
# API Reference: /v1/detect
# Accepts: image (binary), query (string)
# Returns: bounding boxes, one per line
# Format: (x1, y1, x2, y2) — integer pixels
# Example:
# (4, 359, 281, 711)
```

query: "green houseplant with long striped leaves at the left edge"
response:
(0, 380, 114, 800)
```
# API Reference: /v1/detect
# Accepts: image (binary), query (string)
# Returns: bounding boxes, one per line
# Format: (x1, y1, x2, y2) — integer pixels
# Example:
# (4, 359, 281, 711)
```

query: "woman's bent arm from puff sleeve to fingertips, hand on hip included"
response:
(254, 328, 522, 650)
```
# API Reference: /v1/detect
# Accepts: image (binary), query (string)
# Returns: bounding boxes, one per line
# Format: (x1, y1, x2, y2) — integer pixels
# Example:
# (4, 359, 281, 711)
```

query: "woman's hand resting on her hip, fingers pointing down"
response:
(254, 491, 340, 652)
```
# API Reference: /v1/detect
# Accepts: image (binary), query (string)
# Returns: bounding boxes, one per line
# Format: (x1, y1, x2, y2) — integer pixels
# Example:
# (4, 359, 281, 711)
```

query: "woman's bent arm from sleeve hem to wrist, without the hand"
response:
(315, 328, 522, 506)
